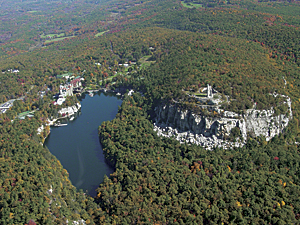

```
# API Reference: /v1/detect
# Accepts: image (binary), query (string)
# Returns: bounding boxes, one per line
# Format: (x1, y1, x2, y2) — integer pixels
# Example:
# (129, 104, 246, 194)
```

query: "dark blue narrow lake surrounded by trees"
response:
(45, 93, 122, 196)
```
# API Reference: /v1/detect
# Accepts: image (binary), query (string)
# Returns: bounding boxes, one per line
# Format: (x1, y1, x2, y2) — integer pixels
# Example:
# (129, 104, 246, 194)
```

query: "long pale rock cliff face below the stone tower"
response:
(154, 96, 292, 149)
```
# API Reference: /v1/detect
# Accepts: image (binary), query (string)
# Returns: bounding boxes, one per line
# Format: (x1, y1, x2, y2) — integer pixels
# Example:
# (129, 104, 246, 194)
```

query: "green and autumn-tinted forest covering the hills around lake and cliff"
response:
(0, 0, 300, 224)
